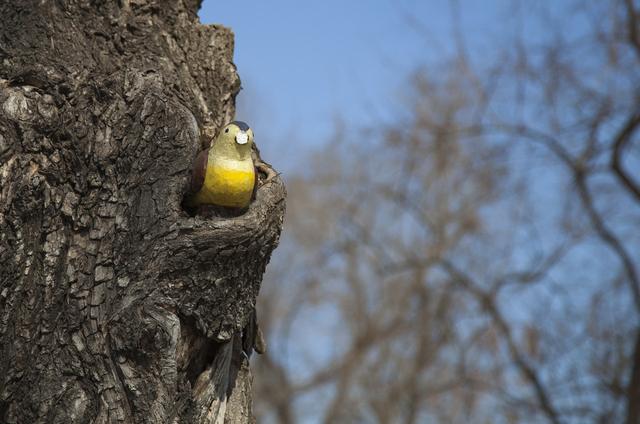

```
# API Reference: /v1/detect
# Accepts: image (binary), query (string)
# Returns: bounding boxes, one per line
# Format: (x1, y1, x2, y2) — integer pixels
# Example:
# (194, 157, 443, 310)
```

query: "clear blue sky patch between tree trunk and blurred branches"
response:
(200, 0, 502, 173)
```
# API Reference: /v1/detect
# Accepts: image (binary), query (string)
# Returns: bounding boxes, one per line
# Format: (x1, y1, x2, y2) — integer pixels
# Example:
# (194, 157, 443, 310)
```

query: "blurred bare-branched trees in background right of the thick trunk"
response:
(255, 0, 640, 423)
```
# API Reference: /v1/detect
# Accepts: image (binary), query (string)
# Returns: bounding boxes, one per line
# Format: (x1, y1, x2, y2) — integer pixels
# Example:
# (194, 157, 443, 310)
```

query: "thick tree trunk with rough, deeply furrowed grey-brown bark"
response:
(0, 0, 285, 423)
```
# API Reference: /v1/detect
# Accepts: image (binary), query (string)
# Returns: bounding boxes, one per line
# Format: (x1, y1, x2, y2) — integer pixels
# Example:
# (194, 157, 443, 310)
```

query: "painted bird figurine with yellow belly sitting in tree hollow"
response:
(186, 121, 257, 209)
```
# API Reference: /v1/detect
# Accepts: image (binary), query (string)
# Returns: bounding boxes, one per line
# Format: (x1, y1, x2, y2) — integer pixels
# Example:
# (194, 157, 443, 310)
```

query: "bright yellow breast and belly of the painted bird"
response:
(194, 159, 255, 208)
